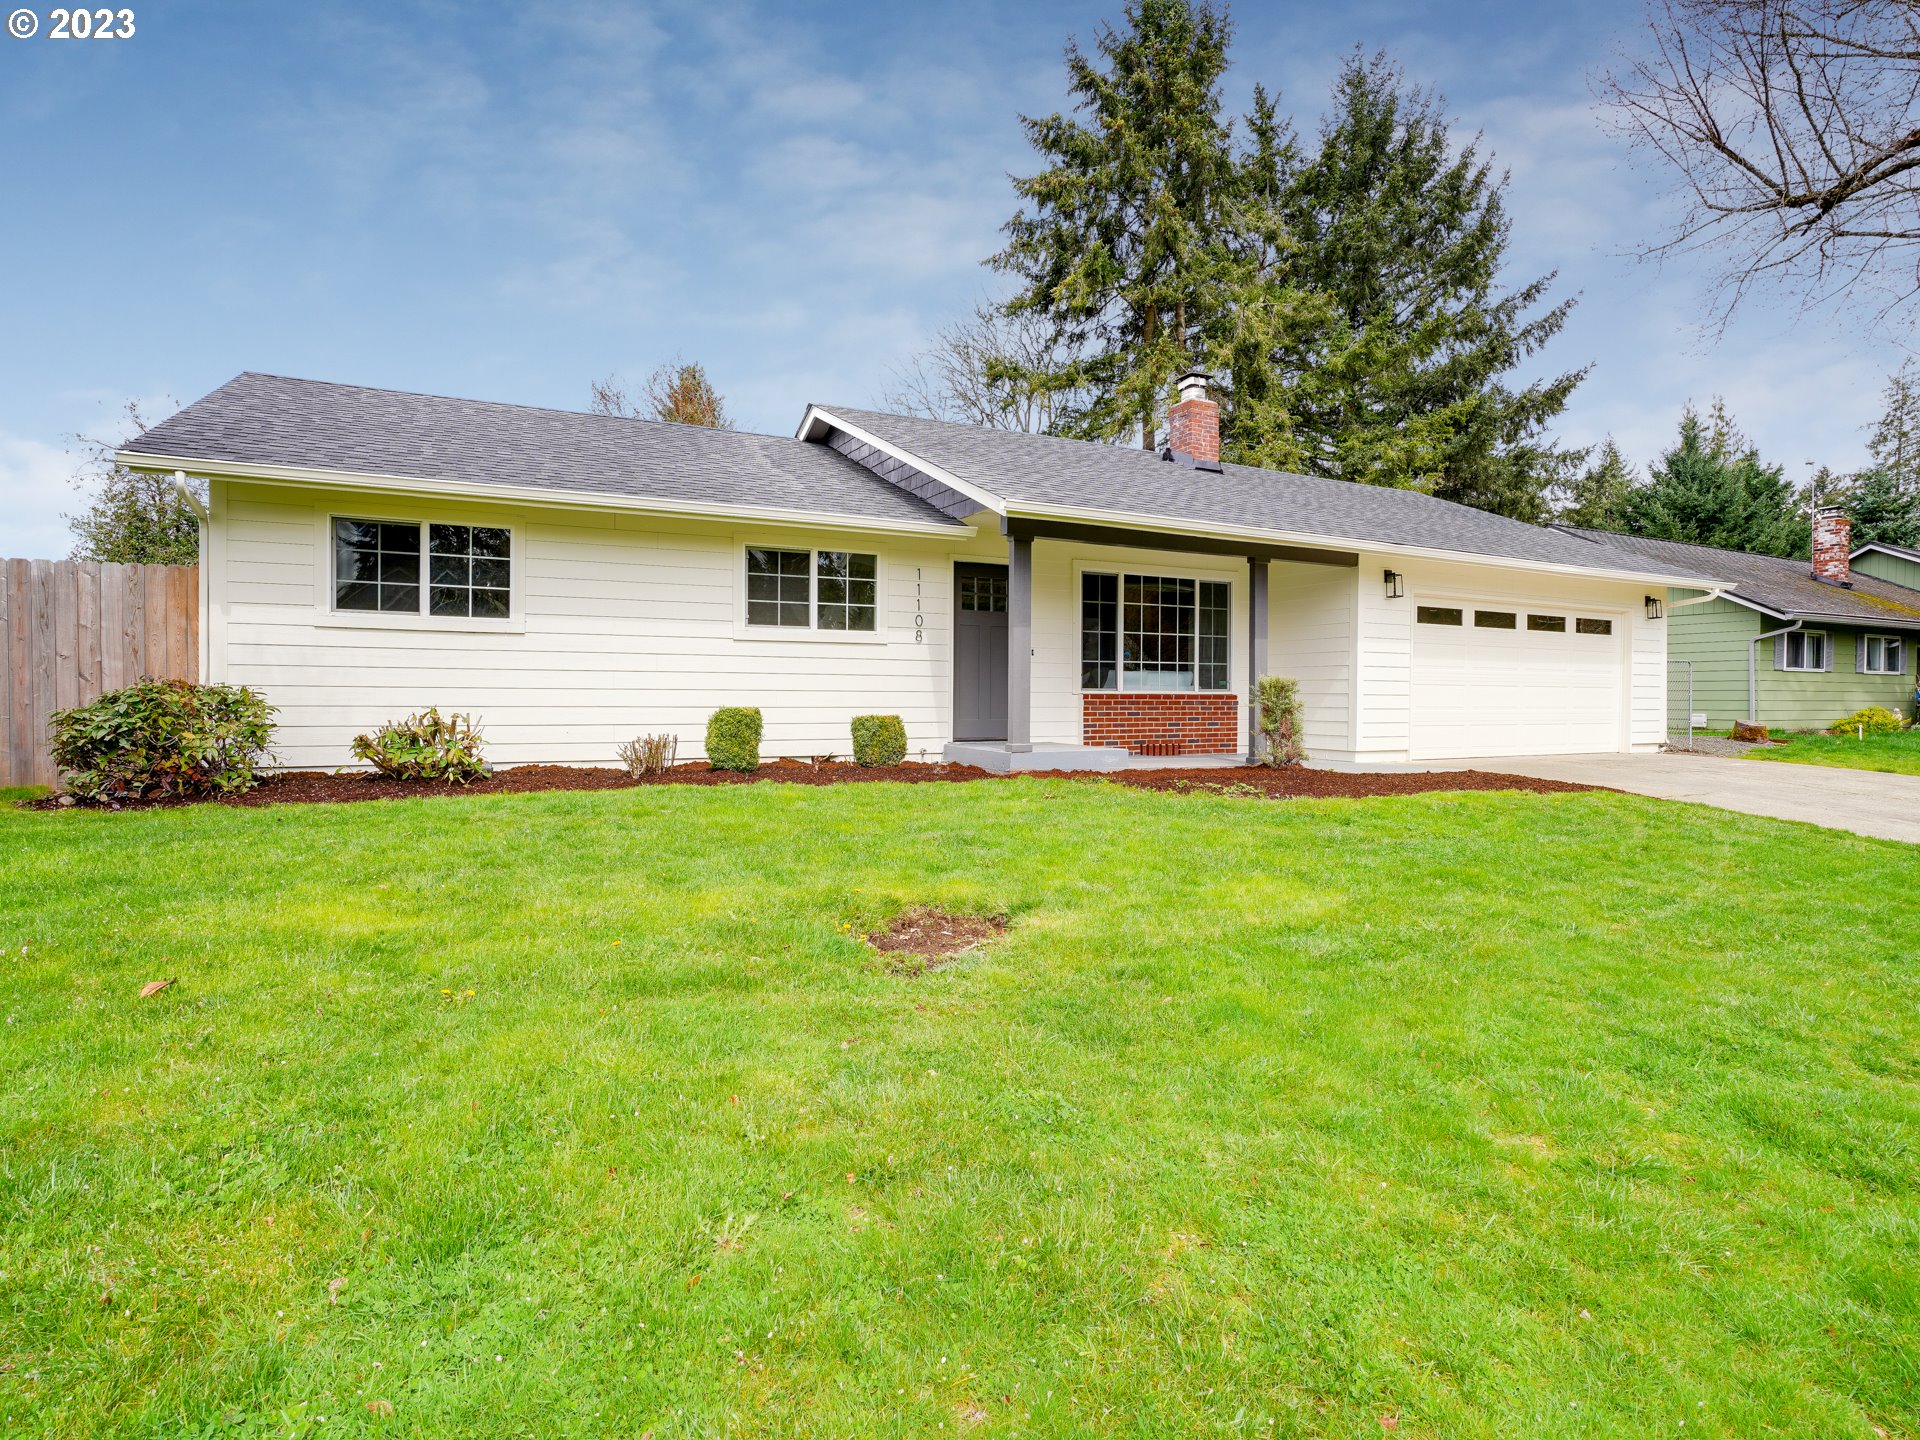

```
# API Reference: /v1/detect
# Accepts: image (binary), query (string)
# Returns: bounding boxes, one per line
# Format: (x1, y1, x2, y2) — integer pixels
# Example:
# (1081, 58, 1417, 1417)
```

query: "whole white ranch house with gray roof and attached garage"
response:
(119, 372, 1716, 770)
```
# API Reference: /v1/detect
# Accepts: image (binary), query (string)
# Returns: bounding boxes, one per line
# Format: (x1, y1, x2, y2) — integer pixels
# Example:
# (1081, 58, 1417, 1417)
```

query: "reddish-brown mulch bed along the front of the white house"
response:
(25, 760, 1596, 810)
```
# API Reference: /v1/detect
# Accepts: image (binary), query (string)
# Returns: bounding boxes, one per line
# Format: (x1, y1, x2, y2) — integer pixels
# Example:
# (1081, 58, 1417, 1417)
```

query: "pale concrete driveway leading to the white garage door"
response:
(1434, 753, 1920, 843)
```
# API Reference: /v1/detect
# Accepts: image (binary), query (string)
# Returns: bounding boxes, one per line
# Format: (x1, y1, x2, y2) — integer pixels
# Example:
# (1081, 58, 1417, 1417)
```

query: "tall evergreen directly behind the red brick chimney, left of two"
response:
(989, 0, 1235, 449)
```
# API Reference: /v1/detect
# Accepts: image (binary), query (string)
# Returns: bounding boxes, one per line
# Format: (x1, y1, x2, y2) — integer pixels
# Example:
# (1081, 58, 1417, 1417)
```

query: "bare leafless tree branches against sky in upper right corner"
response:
(1599, 0, 1920, 324)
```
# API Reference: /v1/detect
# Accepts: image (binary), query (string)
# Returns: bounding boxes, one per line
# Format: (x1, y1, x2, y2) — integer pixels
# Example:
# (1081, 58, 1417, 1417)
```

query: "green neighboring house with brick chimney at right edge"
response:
(1561, 511, 1920, 732)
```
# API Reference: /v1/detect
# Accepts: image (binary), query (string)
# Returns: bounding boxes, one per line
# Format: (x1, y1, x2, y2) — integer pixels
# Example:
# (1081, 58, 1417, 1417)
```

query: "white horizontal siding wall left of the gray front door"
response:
(209, 482, 1004, 766)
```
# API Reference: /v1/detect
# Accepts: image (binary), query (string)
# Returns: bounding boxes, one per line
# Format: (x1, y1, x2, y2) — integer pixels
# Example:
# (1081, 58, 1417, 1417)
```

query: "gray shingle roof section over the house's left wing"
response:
(121, 371, 956, 524)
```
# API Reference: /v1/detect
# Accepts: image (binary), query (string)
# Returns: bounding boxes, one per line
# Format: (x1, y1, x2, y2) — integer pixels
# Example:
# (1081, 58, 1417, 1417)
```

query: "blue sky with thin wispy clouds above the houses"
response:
(0, 0, 1903, 555)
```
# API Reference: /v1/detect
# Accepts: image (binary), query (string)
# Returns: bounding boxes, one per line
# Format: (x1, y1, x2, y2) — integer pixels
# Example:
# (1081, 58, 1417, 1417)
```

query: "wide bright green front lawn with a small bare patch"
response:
(0, 780, 1920, 1440)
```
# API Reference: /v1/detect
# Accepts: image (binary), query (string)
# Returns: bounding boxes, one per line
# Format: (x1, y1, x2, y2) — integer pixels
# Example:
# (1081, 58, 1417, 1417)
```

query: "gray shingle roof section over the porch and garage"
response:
(818, 405, 1713, 582)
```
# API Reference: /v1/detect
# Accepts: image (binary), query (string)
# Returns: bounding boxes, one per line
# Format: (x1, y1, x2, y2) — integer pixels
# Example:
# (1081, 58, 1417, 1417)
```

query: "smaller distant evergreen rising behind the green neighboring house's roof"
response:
(1622, 401, 1812, 555)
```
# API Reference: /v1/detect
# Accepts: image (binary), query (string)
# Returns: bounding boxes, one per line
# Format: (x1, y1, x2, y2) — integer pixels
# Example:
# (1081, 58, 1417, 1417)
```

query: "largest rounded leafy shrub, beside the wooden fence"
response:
(48, 680, 273, 804)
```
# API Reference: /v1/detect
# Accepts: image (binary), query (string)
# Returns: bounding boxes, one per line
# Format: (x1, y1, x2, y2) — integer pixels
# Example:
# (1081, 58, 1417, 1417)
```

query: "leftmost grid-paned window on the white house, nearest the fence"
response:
(334, 520, 513, 620)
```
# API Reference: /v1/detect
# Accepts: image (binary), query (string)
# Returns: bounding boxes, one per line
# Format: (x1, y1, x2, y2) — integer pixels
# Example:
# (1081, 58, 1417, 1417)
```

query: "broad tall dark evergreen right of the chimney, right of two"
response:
(1233, 54, 1586, 520)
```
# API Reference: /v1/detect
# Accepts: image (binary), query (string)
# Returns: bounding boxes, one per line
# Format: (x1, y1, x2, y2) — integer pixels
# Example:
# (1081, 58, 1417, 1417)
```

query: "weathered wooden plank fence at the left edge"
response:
(0, 561, 200, 785)
